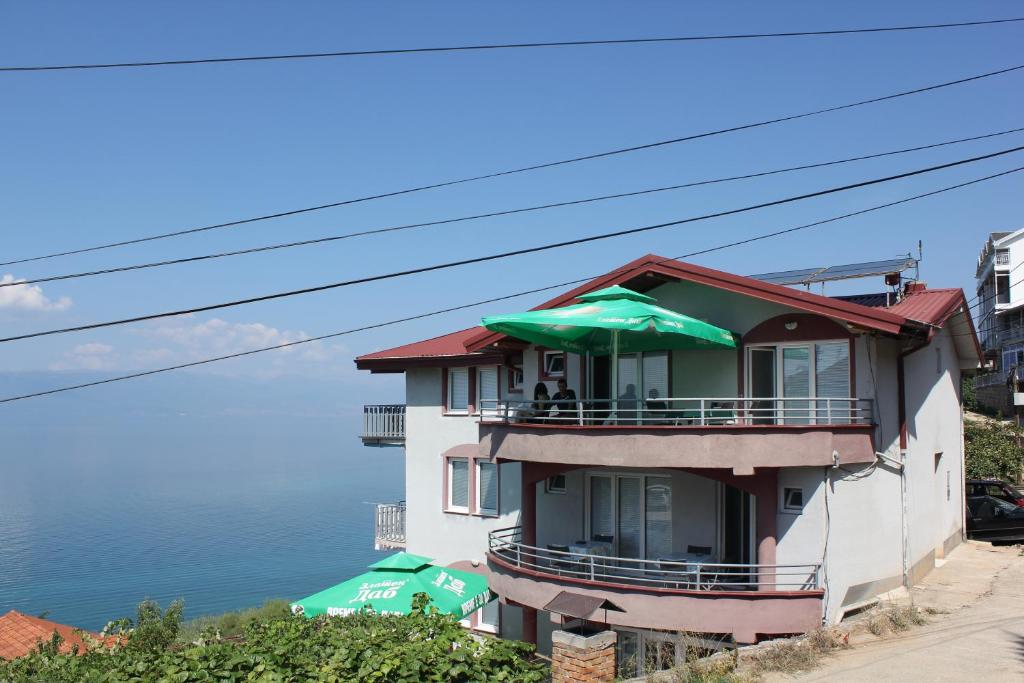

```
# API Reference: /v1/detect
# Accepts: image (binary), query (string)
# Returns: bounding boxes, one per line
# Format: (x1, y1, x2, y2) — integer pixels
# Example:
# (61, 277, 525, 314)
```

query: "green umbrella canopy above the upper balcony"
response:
(482, 285, 736, 355)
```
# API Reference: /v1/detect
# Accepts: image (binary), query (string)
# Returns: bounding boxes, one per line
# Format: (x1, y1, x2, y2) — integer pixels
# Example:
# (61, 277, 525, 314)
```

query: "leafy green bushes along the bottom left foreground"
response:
(0, 596, 548, 683)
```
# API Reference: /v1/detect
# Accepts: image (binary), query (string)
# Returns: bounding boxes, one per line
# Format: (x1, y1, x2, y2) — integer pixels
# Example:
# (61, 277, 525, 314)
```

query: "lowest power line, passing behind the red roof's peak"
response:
(0, 162, 1024, 403)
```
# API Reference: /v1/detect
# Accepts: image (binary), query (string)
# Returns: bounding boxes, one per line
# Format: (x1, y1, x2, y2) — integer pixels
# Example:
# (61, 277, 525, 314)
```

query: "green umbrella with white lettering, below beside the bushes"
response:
(292, 553, 490, 618)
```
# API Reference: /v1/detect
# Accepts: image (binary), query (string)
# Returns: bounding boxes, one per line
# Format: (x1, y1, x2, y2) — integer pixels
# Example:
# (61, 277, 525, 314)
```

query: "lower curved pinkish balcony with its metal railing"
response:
(487, 527, 823, 643)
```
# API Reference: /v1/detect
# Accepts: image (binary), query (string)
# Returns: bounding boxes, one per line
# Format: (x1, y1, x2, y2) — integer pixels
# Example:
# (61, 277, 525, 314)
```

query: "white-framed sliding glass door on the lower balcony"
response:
(587, 473, 672, 559)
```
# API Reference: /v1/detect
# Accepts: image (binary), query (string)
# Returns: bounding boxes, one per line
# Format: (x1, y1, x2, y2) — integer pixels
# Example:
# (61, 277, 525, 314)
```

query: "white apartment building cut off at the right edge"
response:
(975, 229, 1024, 416)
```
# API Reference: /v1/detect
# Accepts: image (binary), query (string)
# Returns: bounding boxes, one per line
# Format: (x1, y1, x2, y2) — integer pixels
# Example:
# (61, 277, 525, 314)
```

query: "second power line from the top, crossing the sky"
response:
(0, 65, 1024, 266)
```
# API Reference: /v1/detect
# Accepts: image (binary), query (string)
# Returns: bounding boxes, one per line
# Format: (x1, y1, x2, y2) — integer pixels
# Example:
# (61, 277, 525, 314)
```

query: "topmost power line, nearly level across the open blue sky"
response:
(0, 17, 1024, 73)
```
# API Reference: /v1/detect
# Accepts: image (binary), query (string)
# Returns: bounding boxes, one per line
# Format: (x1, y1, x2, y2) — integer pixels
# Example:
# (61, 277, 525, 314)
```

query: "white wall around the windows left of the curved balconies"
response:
(406, 368, 520, 564)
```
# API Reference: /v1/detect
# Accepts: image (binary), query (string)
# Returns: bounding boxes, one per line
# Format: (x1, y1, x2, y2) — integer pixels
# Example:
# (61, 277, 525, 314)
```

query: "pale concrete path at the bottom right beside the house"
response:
(765, 543, 1024, 683)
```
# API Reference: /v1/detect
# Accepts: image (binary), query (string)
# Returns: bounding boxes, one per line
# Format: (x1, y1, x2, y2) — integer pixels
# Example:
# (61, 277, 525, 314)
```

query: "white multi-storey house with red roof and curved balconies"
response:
(356, 256, 980, 675)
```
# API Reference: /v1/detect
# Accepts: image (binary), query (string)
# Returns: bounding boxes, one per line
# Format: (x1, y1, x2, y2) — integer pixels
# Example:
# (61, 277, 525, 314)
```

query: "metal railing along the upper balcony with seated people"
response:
(480, 397, 874, 427)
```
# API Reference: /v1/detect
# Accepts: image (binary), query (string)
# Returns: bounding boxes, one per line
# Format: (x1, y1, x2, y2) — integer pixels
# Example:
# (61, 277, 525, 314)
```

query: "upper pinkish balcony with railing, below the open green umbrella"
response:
(480, 397, 876, 474)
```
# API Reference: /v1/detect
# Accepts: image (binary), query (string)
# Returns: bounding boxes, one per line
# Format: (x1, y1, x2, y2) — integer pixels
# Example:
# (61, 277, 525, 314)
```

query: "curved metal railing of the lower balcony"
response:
(487, 526, 821, 591)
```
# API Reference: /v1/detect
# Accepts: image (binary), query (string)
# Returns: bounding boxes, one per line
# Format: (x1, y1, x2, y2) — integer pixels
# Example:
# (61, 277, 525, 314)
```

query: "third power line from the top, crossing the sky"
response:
(8, 127, 1024, 288)
